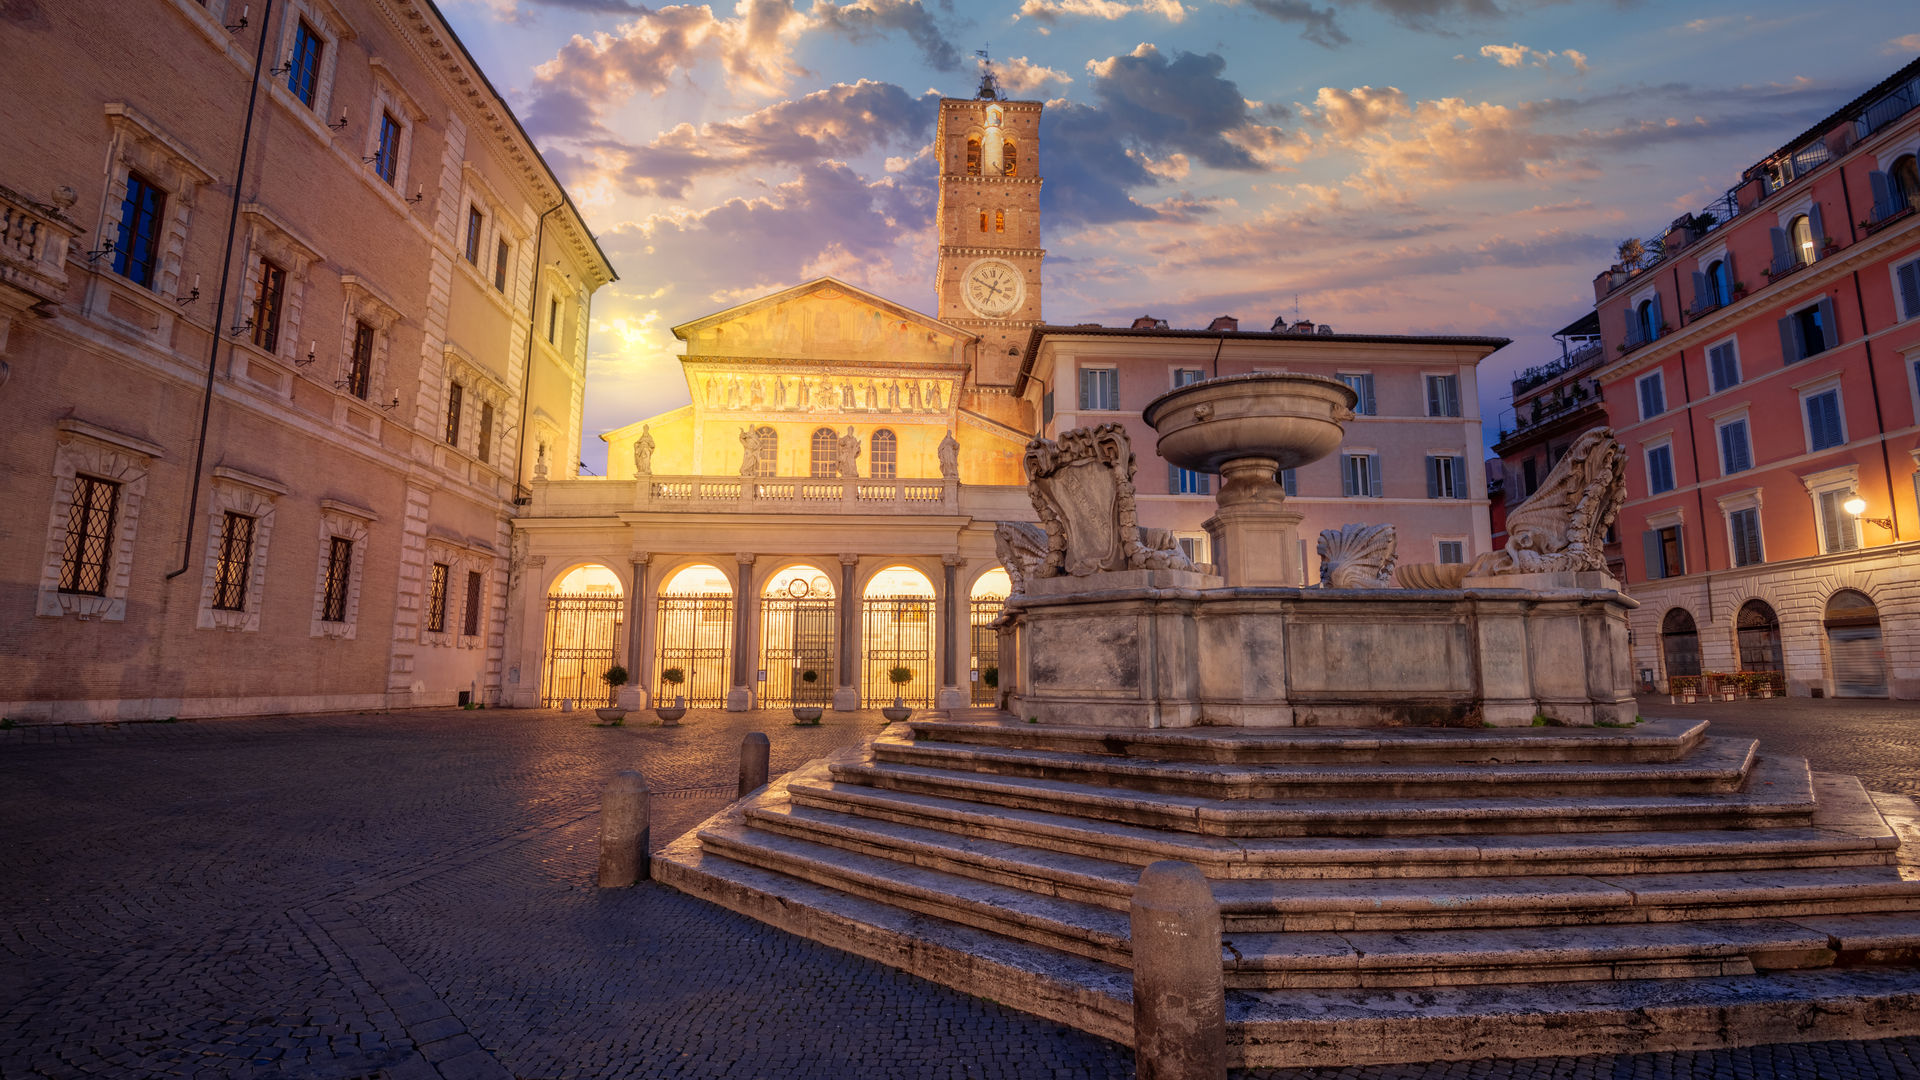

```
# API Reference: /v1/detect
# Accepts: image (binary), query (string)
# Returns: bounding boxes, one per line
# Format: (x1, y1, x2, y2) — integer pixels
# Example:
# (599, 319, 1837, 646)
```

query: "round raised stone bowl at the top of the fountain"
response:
(1144, 371, 1359, 473)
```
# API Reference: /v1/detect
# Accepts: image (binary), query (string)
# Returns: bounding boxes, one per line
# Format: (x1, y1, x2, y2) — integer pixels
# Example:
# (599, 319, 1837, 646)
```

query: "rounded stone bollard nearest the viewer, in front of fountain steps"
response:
(1131, 859, 1227, 1080)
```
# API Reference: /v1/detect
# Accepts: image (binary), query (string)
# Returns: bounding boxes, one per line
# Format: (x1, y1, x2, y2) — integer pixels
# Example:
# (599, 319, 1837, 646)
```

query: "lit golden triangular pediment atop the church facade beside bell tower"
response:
(674, 277, 975, 363)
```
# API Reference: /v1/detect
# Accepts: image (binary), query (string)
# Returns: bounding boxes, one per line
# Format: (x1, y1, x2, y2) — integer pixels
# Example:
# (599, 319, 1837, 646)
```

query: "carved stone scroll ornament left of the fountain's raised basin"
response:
(1008, 425, 1192, 578)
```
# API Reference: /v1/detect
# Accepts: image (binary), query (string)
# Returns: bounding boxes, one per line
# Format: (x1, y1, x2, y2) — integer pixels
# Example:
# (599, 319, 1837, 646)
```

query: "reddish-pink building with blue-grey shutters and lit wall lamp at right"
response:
(1594, 61, 1920, 698)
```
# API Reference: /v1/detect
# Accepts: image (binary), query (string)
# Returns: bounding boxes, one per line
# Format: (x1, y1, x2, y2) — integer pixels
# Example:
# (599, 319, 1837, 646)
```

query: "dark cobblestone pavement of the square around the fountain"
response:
(0, 700, 1920, 1080)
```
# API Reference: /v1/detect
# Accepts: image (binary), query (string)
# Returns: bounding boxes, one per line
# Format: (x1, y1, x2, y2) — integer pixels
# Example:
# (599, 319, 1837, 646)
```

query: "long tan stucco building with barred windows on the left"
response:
(0, 0, 612, 721)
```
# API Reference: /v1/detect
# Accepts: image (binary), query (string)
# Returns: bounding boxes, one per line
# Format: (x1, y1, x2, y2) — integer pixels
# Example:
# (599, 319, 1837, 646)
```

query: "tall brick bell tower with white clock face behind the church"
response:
(933, 71, 1046, 395)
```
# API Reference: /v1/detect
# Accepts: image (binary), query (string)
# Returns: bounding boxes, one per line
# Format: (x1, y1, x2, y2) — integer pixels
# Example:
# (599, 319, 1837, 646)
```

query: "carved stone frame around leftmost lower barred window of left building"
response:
(35, 417, 163, 623)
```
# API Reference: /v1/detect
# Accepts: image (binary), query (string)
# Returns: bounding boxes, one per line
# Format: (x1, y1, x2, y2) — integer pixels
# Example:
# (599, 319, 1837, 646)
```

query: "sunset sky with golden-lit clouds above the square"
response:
(440, 0, 1920, 473)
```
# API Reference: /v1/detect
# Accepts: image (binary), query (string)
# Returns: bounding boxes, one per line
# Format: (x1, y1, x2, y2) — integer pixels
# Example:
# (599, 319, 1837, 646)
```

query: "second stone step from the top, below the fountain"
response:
(874, 732, 1759, 799)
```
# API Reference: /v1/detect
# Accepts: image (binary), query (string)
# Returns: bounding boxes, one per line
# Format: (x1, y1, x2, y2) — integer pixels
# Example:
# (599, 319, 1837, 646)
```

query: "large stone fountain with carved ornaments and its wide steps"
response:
(655, 375, 1920, 1067)
